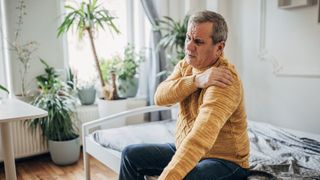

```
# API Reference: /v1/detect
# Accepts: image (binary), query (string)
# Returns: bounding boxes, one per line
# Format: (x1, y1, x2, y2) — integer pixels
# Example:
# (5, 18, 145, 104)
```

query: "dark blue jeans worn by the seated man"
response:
(119, 144, 247, 180)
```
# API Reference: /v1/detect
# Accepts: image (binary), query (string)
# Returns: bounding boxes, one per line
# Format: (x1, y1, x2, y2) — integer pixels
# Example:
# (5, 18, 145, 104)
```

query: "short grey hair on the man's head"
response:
(188, 10, 228, 44)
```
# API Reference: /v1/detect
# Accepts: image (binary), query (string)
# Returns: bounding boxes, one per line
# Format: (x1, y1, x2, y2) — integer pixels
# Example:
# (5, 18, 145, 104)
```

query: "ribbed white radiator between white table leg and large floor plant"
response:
(0, 121, 48, 161)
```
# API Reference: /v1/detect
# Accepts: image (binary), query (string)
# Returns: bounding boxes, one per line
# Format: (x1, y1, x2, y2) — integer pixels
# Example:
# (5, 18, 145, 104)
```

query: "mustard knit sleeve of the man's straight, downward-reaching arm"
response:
(159, 78, 242, 180)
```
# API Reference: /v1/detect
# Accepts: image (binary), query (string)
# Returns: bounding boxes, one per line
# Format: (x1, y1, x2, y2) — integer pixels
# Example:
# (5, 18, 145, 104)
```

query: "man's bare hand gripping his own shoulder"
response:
(195, 67, 233, 88)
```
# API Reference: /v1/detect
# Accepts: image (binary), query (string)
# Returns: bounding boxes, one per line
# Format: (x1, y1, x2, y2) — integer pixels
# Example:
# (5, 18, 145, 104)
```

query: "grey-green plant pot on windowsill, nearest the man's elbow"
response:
(118, 77, 139, 98)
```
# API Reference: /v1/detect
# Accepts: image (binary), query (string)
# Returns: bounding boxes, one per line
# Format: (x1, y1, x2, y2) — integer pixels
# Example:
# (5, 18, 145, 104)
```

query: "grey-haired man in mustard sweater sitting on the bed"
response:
(119, 11, 249, 180)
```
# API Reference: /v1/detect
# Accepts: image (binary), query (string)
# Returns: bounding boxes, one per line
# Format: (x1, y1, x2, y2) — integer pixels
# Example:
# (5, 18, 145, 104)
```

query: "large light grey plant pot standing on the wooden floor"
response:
(48, 137, 80, 165)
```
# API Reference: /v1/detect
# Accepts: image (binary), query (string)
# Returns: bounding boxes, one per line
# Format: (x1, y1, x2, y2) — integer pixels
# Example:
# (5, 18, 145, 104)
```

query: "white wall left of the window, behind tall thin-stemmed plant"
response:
(6, 0, 64, 94)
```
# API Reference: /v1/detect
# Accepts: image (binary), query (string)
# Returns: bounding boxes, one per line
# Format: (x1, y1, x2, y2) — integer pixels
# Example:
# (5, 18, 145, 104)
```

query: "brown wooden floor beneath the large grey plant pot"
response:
(0, 153, 118, 180)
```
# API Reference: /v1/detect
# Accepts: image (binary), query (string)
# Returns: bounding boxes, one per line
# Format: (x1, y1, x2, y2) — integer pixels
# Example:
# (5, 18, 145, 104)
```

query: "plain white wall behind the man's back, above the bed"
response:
(212, 0, 320, 134)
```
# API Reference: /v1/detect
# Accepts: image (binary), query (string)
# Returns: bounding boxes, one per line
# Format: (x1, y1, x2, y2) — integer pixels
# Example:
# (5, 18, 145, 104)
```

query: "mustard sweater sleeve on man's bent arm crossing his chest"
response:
(154, 61, 197, 106)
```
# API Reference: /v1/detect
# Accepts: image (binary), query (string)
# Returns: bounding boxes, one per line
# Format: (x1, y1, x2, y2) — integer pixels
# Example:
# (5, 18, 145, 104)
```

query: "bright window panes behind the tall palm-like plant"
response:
(66, 0, 150, 90)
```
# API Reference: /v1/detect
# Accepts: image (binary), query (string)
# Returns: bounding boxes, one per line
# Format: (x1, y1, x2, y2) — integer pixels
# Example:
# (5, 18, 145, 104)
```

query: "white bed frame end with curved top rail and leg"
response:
(82, 106, 172, 180)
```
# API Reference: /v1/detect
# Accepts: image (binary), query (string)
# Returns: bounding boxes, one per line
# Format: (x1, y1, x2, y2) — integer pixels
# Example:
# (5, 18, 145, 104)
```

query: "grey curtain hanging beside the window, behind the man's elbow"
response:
(141, 0, 171, 121)
